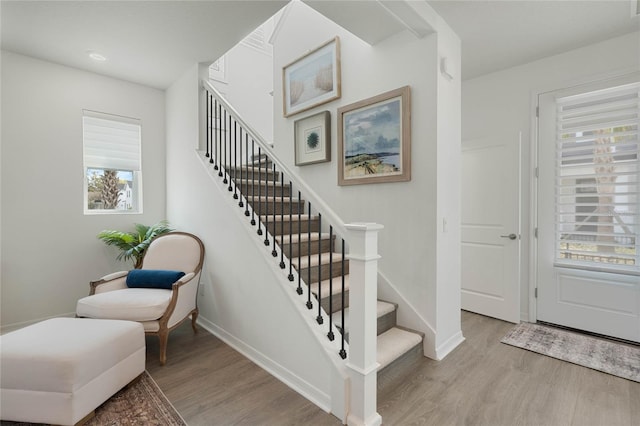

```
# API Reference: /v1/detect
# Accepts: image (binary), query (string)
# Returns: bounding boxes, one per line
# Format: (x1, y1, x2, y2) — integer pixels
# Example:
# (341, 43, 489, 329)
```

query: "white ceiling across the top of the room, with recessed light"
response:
(0, 0, 640, 88)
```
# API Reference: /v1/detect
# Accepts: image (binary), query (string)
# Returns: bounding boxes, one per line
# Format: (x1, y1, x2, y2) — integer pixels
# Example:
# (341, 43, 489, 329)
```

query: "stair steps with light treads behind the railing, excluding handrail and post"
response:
(230, 154, 423, 377)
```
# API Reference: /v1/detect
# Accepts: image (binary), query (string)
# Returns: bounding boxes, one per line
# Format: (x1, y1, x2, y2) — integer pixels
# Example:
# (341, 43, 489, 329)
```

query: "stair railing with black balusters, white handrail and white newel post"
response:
(202, 80, 382, 425)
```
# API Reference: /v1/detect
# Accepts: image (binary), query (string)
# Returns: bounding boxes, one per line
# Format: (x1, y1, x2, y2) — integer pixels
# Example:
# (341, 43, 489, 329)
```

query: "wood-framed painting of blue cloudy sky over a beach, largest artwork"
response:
(338, 86, 411, 185)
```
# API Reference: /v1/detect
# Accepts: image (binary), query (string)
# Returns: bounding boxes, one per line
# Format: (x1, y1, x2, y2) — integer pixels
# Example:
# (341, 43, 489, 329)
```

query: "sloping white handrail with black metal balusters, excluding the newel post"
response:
(202, 80, 349, 359)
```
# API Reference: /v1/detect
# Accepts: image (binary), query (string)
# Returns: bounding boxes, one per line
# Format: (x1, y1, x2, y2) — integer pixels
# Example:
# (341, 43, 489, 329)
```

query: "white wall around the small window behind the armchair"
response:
(1, 51, 165, 329)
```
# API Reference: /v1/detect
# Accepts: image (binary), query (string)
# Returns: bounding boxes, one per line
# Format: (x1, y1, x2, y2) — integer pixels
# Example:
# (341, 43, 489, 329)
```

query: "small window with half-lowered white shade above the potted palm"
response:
(82, 110, 142, 214)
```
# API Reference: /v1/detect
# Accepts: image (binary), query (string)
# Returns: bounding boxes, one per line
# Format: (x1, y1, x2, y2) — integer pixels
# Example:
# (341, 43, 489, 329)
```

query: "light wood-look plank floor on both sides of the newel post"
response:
(147, 312, 640, 426)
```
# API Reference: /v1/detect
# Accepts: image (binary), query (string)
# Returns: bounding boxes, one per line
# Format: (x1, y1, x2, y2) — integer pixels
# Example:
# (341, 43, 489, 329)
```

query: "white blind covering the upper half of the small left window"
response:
(82, 110, 141, 171)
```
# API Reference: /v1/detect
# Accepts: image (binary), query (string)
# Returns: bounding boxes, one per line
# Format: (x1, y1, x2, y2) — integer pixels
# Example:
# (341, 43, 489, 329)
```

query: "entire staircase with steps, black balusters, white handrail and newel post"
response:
(203, 81, 423, 424)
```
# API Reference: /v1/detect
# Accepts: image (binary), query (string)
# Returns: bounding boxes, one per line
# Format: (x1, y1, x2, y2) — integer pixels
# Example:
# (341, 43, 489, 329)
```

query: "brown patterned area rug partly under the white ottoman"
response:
(2, 371, 187, 426)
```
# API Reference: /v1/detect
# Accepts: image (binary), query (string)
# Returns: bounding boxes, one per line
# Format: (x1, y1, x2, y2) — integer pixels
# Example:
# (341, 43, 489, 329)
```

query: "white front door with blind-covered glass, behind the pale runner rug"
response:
(536, 73, 640, 342)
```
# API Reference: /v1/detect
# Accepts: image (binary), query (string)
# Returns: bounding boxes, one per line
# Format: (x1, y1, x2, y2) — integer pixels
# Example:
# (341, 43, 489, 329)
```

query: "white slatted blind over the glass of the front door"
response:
(556, 83, 640, 270)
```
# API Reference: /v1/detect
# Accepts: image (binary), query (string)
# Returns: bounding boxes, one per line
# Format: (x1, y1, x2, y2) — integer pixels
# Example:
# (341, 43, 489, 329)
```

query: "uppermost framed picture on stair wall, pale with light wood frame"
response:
(282, 37, 341, 117)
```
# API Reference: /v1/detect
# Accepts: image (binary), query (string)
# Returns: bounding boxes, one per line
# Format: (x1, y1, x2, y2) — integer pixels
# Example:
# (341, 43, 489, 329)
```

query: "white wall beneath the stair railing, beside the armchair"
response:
(166, 65, 344, 416)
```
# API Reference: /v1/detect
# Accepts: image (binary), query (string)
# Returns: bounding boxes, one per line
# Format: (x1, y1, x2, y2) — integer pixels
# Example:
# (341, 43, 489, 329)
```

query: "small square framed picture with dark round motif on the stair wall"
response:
(294, 111, 331, 166)
